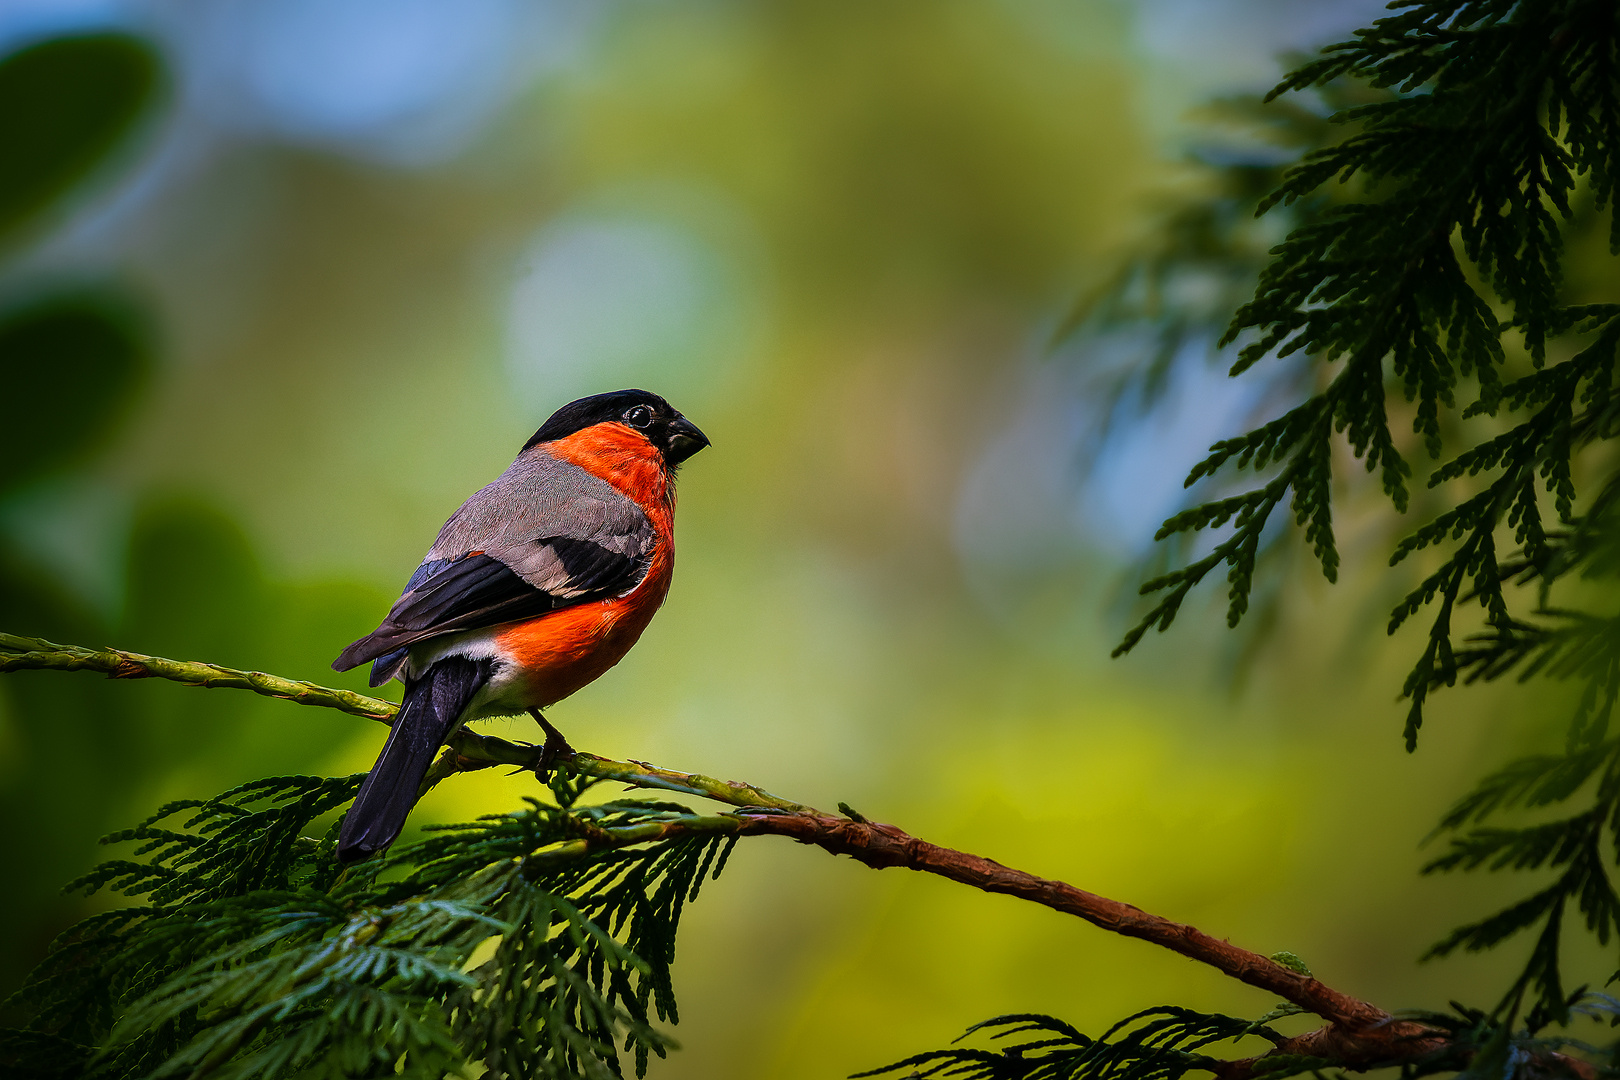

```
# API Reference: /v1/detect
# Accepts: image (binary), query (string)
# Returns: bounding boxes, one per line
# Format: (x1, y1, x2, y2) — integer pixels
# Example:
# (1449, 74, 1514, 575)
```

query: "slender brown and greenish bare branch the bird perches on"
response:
(0, 633, 1574, 1080)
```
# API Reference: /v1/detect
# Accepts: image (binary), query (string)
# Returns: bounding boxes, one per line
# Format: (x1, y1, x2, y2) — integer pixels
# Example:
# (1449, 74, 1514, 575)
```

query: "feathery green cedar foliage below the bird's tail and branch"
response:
(0, 776, 735, 1080)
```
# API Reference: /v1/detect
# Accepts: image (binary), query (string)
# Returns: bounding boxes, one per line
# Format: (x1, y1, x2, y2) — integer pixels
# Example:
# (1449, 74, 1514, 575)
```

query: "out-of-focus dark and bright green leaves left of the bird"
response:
(0, 25, 365, 1010)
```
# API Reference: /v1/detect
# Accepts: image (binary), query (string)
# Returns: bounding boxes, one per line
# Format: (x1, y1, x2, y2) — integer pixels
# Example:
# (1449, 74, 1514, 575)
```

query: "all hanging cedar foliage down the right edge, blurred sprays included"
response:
(1082, 0, 1620, 1049)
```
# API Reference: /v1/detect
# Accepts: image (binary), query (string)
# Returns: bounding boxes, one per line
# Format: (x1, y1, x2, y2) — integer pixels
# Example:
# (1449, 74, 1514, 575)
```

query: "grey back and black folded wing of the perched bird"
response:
(332, 455, 656, 687)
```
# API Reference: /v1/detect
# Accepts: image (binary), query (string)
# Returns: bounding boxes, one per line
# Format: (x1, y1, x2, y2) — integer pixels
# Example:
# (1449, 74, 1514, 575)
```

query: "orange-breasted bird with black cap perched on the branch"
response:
(332, 390, 710, 863)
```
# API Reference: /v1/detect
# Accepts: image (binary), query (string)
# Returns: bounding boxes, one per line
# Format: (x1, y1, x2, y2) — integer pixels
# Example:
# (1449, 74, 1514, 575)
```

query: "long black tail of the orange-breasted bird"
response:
(337, 656, 489, 863)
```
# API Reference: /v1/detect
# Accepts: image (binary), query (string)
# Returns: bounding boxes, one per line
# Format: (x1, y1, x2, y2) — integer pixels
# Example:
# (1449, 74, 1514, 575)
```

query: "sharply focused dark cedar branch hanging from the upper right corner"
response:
(1116, 0, 1620, 725)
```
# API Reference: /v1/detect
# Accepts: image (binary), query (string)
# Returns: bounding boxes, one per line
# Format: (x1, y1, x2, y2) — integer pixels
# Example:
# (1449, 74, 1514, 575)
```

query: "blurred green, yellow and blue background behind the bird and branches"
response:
(0, 0, 1581, 1078)
